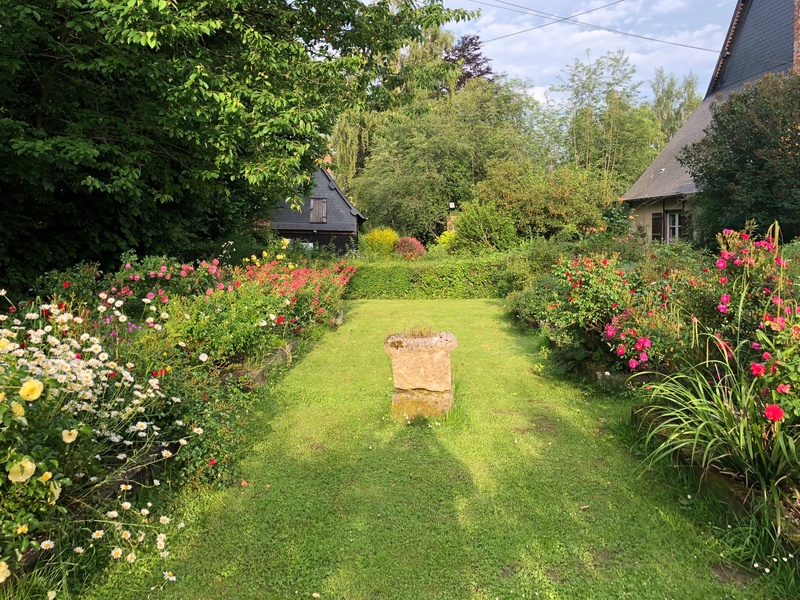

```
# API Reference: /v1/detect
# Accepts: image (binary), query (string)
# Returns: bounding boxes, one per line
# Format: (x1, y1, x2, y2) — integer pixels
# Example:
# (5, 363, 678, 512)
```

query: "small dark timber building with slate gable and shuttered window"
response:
(270, 169, 366, 252)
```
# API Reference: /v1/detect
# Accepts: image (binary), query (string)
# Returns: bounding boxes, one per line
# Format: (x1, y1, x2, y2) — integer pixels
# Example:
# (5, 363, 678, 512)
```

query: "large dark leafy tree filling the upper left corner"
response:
(0, 0, 466, 283)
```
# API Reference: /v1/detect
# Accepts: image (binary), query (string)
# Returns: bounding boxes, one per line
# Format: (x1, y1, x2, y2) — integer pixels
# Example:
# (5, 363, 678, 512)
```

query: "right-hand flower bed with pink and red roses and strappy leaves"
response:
(512, 227, 800, 556)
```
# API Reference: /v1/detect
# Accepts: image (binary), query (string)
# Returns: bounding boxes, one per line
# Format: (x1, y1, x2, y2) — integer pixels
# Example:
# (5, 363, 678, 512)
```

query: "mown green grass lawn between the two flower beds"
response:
(87, 300, 770, 600)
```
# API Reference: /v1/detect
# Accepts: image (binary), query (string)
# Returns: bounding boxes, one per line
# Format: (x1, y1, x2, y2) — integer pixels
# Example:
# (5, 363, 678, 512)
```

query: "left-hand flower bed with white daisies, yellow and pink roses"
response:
(0, 252, 354, 589)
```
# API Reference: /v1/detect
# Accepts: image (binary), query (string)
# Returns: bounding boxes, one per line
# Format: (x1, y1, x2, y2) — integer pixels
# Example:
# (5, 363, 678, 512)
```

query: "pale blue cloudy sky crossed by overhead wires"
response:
(444, 0, 737, 99)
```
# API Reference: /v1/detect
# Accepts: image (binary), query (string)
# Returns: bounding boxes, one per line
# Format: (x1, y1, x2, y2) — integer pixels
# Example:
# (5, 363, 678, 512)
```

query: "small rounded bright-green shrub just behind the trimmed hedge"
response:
(450, 202, 517, 252)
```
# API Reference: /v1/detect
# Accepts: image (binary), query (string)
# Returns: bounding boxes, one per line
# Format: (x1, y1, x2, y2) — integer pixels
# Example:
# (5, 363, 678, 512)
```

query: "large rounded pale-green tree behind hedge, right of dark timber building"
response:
(352, 79, 531, 244)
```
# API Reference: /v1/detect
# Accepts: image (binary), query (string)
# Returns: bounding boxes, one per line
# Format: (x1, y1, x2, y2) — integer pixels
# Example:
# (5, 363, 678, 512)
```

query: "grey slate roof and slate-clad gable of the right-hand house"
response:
(622, 0, 795, 200)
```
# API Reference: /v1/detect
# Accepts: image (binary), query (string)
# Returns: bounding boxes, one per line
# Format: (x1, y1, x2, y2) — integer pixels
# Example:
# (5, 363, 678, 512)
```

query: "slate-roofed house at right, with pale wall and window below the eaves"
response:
(623, 0, 800, 241)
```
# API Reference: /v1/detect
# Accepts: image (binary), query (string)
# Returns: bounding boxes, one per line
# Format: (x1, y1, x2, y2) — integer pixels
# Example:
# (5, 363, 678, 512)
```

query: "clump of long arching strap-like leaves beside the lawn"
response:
(647, 336, 800, 535)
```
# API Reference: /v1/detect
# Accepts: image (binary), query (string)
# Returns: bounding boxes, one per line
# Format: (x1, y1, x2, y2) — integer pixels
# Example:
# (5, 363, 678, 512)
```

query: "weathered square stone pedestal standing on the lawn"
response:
(384, 333, 458, 419)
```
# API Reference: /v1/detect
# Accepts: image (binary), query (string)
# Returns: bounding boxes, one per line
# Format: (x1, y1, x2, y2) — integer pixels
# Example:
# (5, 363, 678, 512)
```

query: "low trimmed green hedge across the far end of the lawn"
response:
(344, 254, 527, 300)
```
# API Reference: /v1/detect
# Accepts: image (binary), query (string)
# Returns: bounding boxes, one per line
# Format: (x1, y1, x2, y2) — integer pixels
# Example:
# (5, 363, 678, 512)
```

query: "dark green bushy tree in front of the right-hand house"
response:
(680, 75, 800, 243)
